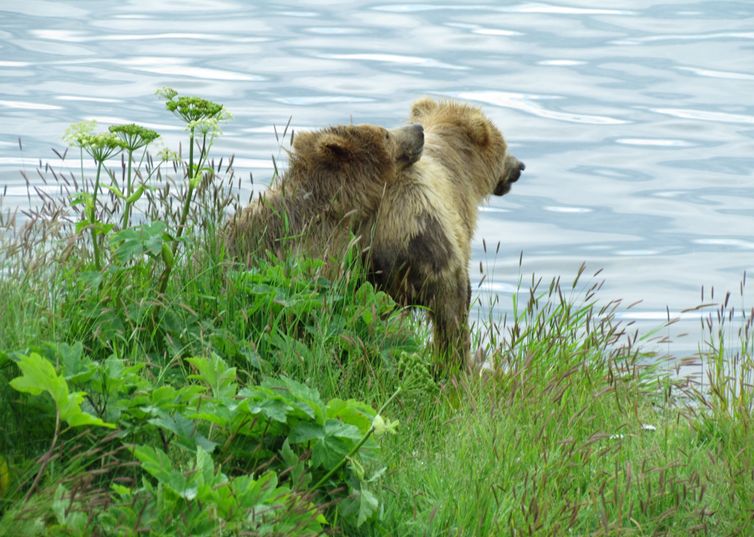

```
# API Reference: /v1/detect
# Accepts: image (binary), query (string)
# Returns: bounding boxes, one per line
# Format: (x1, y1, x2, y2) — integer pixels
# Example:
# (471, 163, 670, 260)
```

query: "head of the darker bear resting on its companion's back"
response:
(287, 125, 424, 216)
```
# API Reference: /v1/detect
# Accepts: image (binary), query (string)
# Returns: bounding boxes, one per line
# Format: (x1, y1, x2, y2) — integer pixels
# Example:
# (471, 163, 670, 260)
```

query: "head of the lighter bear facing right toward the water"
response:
(409, 97, 526, 199)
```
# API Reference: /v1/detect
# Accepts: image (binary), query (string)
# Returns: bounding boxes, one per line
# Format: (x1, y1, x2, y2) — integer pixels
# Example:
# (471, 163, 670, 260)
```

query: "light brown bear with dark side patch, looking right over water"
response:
(362, 97, 525, 370)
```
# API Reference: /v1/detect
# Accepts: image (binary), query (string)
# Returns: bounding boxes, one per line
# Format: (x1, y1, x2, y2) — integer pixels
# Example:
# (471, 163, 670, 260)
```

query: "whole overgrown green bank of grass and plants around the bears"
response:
(0, 92, 754, 536)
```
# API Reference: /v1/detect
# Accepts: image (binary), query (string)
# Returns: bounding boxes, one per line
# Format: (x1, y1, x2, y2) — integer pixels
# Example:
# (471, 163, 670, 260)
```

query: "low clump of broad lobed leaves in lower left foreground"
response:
(0, 344, 395, 535)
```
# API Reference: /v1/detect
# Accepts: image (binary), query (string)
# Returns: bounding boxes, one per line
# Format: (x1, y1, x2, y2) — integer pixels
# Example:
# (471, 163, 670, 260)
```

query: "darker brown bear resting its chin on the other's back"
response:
(225, 125, 424, 274)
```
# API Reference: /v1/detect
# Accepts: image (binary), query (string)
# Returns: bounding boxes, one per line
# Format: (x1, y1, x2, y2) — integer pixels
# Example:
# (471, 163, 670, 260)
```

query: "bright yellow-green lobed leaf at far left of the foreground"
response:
(10, 352, 115, 429)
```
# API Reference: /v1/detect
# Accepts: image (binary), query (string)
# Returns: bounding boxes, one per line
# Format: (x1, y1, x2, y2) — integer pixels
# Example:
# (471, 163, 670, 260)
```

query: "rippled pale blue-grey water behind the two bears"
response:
(0, 0, 754, 360)
